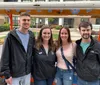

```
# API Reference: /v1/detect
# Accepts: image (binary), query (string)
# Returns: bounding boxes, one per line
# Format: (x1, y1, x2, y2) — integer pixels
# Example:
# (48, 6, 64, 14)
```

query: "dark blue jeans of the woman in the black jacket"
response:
(34, 78, 54, 85)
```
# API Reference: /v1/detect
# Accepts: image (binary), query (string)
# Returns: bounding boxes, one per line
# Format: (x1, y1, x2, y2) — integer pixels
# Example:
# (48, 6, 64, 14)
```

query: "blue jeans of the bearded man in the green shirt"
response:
(77, 77, 100, 85)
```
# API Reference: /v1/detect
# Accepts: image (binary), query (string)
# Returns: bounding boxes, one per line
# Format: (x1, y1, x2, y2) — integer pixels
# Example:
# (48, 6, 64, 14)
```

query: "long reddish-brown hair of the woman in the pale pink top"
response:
(56, 26, 72, 49)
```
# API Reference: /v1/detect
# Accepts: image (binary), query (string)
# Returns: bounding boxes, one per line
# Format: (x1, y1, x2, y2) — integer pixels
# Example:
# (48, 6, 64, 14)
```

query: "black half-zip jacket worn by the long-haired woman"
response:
(33, 46, 56, 80)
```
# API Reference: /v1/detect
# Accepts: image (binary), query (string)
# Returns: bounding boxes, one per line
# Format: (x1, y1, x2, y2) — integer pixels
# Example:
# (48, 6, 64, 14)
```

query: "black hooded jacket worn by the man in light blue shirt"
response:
(0, 30, 35, 78)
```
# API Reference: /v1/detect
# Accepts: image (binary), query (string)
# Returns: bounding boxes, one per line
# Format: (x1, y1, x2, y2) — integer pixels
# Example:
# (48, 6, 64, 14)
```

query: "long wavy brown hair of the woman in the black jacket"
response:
(36, 25, 55, 51)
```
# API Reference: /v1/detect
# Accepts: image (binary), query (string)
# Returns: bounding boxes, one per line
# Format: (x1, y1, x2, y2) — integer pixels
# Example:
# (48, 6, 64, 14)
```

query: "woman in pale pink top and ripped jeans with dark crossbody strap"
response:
(55, 27, 75, 85)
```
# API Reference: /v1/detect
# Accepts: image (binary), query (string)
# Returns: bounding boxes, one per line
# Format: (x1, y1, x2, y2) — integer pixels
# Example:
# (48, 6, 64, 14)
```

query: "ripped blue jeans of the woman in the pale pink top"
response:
(55, 68, 73, 85)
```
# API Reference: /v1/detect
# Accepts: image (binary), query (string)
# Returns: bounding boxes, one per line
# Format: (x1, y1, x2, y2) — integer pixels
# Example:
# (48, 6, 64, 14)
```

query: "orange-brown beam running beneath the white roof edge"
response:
(0, 9, 100, 16)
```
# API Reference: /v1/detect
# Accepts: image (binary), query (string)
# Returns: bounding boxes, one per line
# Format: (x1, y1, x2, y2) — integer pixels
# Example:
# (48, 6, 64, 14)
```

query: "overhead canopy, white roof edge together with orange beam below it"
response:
(0, 1, 100, 17)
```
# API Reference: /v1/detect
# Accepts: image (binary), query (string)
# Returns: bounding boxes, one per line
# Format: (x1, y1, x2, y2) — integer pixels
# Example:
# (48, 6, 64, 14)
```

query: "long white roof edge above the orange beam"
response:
(0, 1, 100, 9)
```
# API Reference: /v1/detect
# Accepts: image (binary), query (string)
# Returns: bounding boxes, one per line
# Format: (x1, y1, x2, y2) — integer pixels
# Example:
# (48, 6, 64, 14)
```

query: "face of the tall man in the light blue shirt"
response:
(19, 16, 31, 29)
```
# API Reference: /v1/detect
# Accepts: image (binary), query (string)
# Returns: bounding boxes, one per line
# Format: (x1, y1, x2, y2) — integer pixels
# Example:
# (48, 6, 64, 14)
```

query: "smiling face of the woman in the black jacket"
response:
(42, 28, 51, 42)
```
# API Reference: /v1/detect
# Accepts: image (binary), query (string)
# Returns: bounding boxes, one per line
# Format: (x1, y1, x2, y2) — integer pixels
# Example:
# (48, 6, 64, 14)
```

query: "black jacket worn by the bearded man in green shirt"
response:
(76, 37, 100, 82)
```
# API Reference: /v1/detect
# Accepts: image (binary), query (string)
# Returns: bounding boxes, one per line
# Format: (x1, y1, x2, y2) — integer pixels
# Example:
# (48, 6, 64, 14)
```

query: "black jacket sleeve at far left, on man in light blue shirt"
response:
(0, 33, 11, 79)
